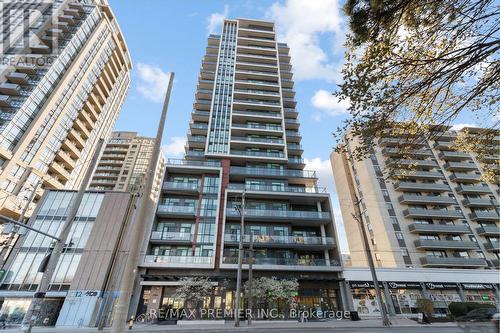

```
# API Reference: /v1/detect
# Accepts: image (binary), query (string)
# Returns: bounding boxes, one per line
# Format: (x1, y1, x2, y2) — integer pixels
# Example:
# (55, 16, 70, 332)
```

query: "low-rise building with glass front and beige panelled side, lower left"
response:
(0, 190, 134, 327)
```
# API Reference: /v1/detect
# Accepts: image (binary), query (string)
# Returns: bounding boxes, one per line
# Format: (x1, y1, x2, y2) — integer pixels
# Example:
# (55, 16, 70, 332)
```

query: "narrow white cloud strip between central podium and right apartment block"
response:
(305, 157, 348, 252)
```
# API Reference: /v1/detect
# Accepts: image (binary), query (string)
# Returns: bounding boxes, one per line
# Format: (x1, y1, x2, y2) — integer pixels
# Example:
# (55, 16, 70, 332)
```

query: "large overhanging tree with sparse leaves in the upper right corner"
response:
(335, 0, 500, 179)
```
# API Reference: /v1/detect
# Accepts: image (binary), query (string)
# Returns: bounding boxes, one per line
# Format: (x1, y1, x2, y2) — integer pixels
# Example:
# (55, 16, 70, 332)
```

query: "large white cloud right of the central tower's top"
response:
(266, 0, 345, 82)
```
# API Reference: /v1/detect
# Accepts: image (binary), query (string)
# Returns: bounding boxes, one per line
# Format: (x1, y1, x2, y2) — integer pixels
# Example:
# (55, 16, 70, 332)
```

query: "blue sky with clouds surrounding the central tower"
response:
(109, 0, 476, 251)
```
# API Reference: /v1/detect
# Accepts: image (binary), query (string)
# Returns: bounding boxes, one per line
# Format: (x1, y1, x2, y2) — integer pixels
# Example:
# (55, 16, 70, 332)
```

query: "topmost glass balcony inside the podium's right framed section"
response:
(226, 207, 331, 220)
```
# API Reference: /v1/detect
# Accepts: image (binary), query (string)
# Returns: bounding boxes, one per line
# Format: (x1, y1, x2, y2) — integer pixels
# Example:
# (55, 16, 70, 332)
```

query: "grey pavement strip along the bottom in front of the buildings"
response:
(0, 318, 456, 333)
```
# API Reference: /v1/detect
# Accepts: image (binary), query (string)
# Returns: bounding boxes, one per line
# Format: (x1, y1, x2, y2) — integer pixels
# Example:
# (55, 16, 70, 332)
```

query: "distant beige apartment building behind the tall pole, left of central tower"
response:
(89, 131, 165, 199)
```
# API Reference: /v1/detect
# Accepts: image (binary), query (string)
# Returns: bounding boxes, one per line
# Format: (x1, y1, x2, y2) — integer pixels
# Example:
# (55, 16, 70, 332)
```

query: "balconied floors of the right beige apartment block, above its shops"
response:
(331, 127, 500, 268)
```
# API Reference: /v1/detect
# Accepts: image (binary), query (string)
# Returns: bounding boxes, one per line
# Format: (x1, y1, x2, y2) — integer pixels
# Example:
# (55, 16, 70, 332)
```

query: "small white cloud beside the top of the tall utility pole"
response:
(137, 63, 170, 102)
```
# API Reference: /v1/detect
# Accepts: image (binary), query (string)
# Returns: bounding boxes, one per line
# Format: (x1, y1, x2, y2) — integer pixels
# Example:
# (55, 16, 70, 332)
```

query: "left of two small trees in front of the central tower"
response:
(175, 276, 213, 316)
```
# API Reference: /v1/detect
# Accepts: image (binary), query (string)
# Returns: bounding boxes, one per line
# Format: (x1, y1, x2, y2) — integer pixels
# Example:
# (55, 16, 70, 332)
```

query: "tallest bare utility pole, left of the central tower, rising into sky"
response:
(111, 73, 174, 333)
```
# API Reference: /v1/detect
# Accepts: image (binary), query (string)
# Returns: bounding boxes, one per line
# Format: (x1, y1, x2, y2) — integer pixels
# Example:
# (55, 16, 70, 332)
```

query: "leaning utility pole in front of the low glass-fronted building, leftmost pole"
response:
(20, 138, 104, 333)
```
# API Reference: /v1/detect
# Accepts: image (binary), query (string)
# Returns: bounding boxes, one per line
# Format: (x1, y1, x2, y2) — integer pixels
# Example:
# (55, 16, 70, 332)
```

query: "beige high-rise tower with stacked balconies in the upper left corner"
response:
(0, 0, 131, 218)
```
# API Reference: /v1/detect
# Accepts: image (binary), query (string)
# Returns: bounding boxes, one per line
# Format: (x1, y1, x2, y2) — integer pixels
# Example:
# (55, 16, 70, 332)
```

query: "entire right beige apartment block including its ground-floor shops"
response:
(331, 126, 500, 315)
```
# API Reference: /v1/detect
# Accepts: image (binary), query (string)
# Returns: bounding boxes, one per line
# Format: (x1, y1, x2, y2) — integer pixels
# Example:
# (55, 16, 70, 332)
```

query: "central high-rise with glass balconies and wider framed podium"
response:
(133, 19, 342, 314)
